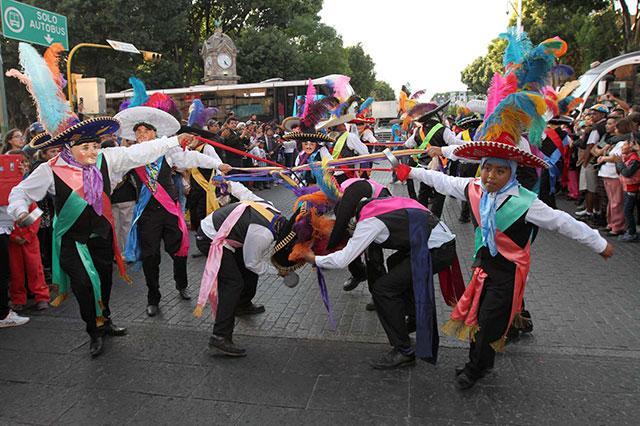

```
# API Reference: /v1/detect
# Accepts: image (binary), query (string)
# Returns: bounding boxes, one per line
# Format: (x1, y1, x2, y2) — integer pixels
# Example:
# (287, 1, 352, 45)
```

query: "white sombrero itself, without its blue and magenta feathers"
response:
(114, 106, 180, 140)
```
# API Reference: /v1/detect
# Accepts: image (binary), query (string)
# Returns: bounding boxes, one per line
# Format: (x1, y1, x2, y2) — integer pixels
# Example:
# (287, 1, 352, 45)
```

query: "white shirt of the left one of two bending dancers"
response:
(200, 182, 278, 275)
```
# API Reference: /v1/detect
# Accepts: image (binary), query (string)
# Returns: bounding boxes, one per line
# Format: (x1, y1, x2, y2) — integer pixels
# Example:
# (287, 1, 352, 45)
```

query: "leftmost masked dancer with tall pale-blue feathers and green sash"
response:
(7, 43, 198, 356)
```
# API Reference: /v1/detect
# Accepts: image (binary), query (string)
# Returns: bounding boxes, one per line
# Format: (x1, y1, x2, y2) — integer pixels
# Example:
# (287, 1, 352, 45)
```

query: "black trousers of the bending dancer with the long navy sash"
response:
(369, 252, 415, 351)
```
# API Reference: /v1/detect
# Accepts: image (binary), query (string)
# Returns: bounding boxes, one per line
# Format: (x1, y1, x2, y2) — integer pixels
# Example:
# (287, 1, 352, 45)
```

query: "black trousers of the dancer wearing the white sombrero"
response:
(138, 204, 189, 305)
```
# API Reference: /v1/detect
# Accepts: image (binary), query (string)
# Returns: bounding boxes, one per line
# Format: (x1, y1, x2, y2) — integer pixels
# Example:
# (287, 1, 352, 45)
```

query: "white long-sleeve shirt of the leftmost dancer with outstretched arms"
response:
(7, 137, 182, 219)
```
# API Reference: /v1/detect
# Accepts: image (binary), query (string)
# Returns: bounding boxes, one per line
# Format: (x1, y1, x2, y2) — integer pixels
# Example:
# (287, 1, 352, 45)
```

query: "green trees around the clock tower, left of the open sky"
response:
(1, 0, 392, 127)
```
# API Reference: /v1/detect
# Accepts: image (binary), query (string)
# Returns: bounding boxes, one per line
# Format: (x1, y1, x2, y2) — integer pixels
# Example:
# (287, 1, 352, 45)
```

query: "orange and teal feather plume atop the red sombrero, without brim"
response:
(476, 91, 547, 146)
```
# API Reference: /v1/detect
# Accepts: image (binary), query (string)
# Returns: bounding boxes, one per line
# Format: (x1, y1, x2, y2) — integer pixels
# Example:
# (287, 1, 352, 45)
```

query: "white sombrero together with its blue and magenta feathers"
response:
(114, 77, 180, 140)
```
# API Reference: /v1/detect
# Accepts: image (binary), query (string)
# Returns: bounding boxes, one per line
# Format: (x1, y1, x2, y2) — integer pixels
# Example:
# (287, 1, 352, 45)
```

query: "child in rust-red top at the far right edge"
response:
(617, 140, 640, 242)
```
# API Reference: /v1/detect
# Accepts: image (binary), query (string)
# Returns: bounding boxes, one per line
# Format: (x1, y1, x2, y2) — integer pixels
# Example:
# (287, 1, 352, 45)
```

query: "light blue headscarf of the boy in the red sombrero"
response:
(480, 157, 518, 256)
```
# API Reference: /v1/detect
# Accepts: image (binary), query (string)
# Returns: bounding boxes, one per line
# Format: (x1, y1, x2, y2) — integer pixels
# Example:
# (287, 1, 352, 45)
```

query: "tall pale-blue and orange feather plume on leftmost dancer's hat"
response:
(7, 43, 79, 136)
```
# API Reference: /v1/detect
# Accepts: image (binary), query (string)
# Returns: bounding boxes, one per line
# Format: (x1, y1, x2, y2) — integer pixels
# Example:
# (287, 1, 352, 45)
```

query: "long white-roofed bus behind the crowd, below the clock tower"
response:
(106, 74, 353, 122)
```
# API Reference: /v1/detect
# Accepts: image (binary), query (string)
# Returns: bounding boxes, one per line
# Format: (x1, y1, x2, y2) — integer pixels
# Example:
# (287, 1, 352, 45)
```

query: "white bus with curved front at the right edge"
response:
(572, 51, 640, 110)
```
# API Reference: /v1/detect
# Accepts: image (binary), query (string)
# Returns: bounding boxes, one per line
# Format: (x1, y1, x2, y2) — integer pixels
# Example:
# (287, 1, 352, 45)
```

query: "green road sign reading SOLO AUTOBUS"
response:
(0, 0, 69, 50)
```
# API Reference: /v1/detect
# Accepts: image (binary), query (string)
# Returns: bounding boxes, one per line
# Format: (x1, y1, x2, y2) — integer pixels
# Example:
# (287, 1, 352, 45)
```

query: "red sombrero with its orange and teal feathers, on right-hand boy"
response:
(453, 91, 548, 168)
